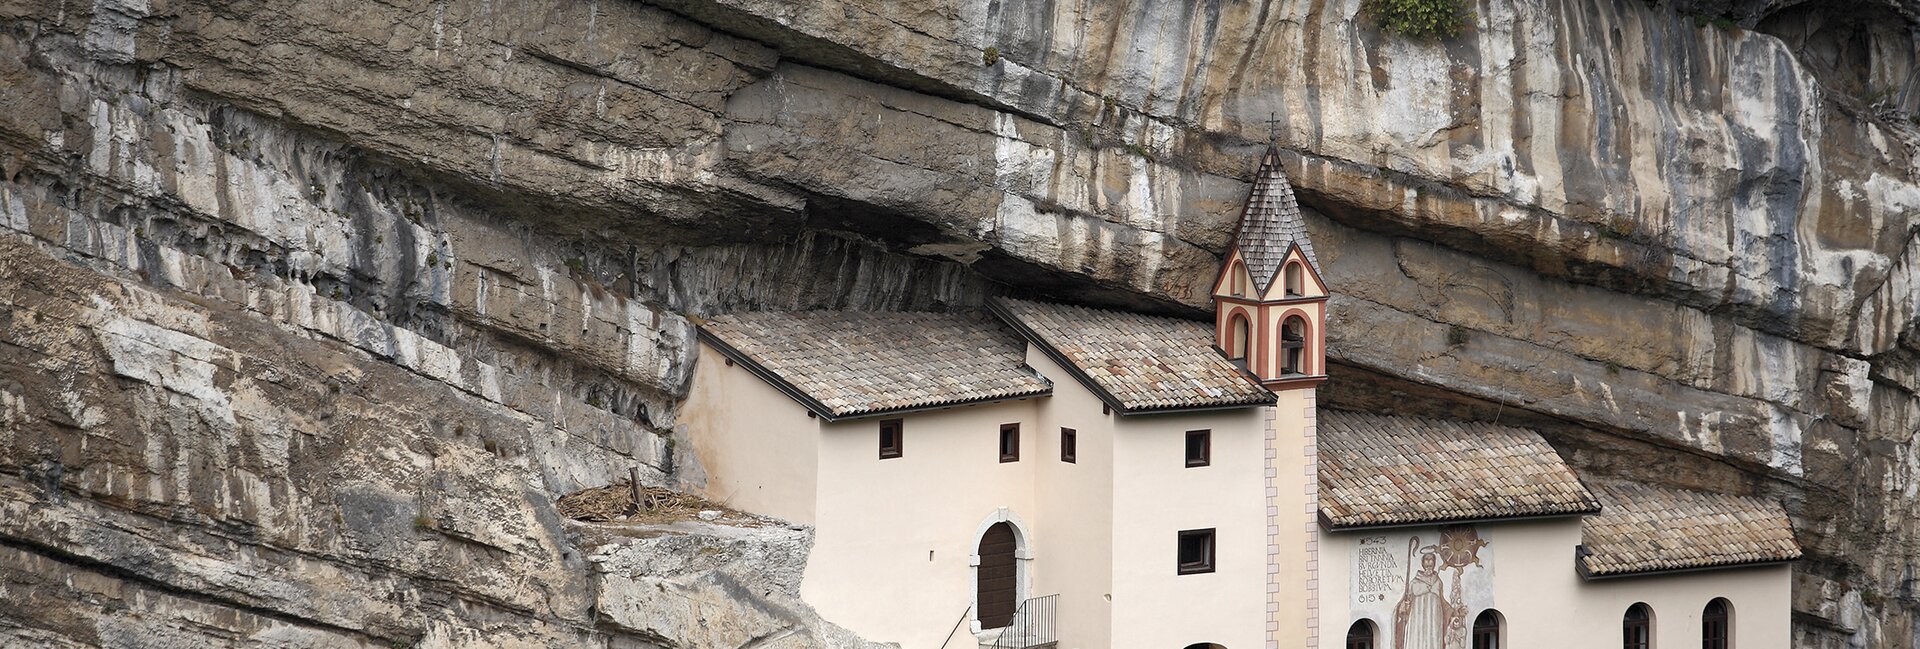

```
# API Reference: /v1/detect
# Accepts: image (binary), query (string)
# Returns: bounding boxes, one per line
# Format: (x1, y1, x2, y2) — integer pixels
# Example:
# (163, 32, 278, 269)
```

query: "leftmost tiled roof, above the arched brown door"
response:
(701, 311, 1052, 419)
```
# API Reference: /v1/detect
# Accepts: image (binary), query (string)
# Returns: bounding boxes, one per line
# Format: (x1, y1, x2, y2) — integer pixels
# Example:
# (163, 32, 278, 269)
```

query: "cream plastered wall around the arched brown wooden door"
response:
(801, 399, 1058, 649)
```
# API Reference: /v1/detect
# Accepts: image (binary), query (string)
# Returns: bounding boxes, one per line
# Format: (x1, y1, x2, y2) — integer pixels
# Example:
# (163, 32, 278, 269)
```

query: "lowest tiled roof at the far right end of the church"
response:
(1578, 482, 1801, 576)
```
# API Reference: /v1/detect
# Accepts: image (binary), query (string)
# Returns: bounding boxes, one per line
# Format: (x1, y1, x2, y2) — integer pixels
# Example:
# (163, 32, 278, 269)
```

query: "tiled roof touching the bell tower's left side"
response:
(995, 300, 1273, 413)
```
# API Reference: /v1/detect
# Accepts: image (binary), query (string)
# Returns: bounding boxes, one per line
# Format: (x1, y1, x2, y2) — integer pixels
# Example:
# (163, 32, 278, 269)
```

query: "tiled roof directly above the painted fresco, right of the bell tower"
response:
(1317, 409, 1599, 528)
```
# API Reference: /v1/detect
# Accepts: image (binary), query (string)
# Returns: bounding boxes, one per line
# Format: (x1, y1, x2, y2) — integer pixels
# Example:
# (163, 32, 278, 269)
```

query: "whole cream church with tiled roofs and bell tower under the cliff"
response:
(680, 148, 1799, 649)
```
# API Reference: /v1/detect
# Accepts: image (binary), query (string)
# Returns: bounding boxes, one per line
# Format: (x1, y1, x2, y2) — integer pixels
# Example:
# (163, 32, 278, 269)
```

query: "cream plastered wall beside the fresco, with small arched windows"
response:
(1319, 518, 1791, 649)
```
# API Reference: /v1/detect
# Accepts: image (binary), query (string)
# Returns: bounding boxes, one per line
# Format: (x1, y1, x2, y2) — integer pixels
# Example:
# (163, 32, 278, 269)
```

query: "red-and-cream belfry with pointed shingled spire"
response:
(1213, 144, 1327, 390)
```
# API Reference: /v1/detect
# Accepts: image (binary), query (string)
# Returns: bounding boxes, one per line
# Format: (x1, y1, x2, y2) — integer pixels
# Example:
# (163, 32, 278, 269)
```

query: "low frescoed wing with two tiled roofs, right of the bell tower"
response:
(1315, 409, 1799, 649)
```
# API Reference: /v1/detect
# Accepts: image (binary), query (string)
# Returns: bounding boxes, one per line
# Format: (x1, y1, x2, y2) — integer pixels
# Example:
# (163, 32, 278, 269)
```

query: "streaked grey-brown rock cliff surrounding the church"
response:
(0, 0, 1920, 647)
